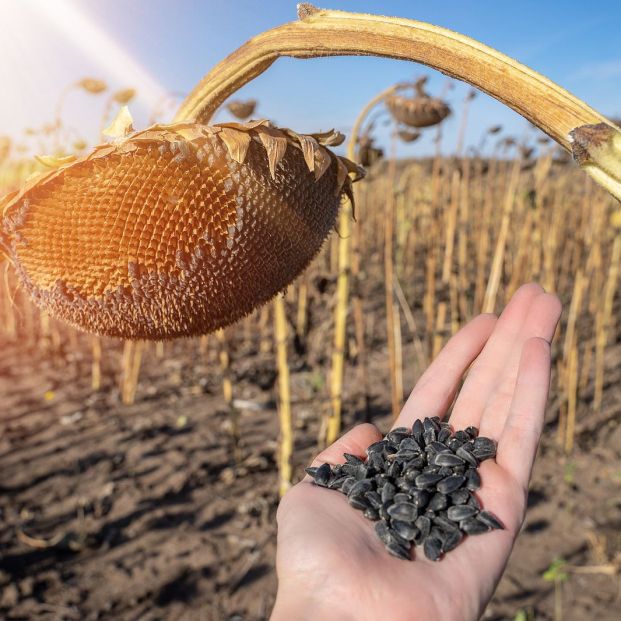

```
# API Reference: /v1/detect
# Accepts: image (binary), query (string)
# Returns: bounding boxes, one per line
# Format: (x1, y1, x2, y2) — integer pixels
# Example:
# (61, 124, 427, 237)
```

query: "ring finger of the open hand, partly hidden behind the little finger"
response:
(481, 293, 561, 439)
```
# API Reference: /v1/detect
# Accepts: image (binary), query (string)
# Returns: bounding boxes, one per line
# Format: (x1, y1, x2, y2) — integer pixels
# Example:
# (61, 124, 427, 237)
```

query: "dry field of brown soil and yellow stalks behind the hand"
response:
(0, 155, 621, 620)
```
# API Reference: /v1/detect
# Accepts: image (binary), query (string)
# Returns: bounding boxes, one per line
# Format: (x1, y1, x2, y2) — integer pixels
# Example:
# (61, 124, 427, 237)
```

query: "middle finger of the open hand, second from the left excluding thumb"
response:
(451, 283, 543, 429)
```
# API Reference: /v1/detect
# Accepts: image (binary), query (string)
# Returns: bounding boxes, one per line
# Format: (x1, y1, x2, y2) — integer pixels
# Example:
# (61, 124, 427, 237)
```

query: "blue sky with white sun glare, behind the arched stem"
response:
(0, 0, 621, 155)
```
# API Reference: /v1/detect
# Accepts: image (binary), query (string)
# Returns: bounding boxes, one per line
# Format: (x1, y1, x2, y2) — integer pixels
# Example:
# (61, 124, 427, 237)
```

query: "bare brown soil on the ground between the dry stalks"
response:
(0, 292, 621, 621)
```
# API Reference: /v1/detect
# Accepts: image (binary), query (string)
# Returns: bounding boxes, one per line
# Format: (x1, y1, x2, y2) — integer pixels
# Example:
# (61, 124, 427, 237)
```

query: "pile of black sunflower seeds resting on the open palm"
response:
(306, 416, 503, 561)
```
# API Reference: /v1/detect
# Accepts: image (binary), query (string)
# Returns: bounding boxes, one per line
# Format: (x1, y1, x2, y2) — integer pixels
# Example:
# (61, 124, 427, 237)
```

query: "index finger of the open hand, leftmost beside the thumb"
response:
(393, 313, 496, 427)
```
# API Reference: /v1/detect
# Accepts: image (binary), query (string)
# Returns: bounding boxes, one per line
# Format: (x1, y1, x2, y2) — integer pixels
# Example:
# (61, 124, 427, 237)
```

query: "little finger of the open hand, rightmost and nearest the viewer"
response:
(496, 338, 550, 490)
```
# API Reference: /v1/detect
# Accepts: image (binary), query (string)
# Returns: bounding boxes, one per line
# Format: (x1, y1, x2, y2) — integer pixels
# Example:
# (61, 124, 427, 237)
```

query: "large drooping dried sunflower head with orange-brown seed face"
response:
(0, 121, 361, 340)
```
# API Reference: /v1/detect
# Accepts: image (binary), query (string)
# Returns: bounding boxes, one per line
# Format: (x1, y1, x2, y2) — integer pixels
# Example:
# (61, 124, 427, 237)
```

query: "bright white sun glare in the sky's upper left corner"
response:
(0, 0, 166, 138)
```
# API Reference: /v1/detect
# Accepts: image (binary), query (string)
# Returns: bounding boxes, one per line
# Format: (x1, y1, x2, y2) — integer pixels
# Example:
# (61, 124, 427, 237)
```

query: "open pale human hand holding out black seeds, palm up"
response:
(272, 284, 561, 621)
